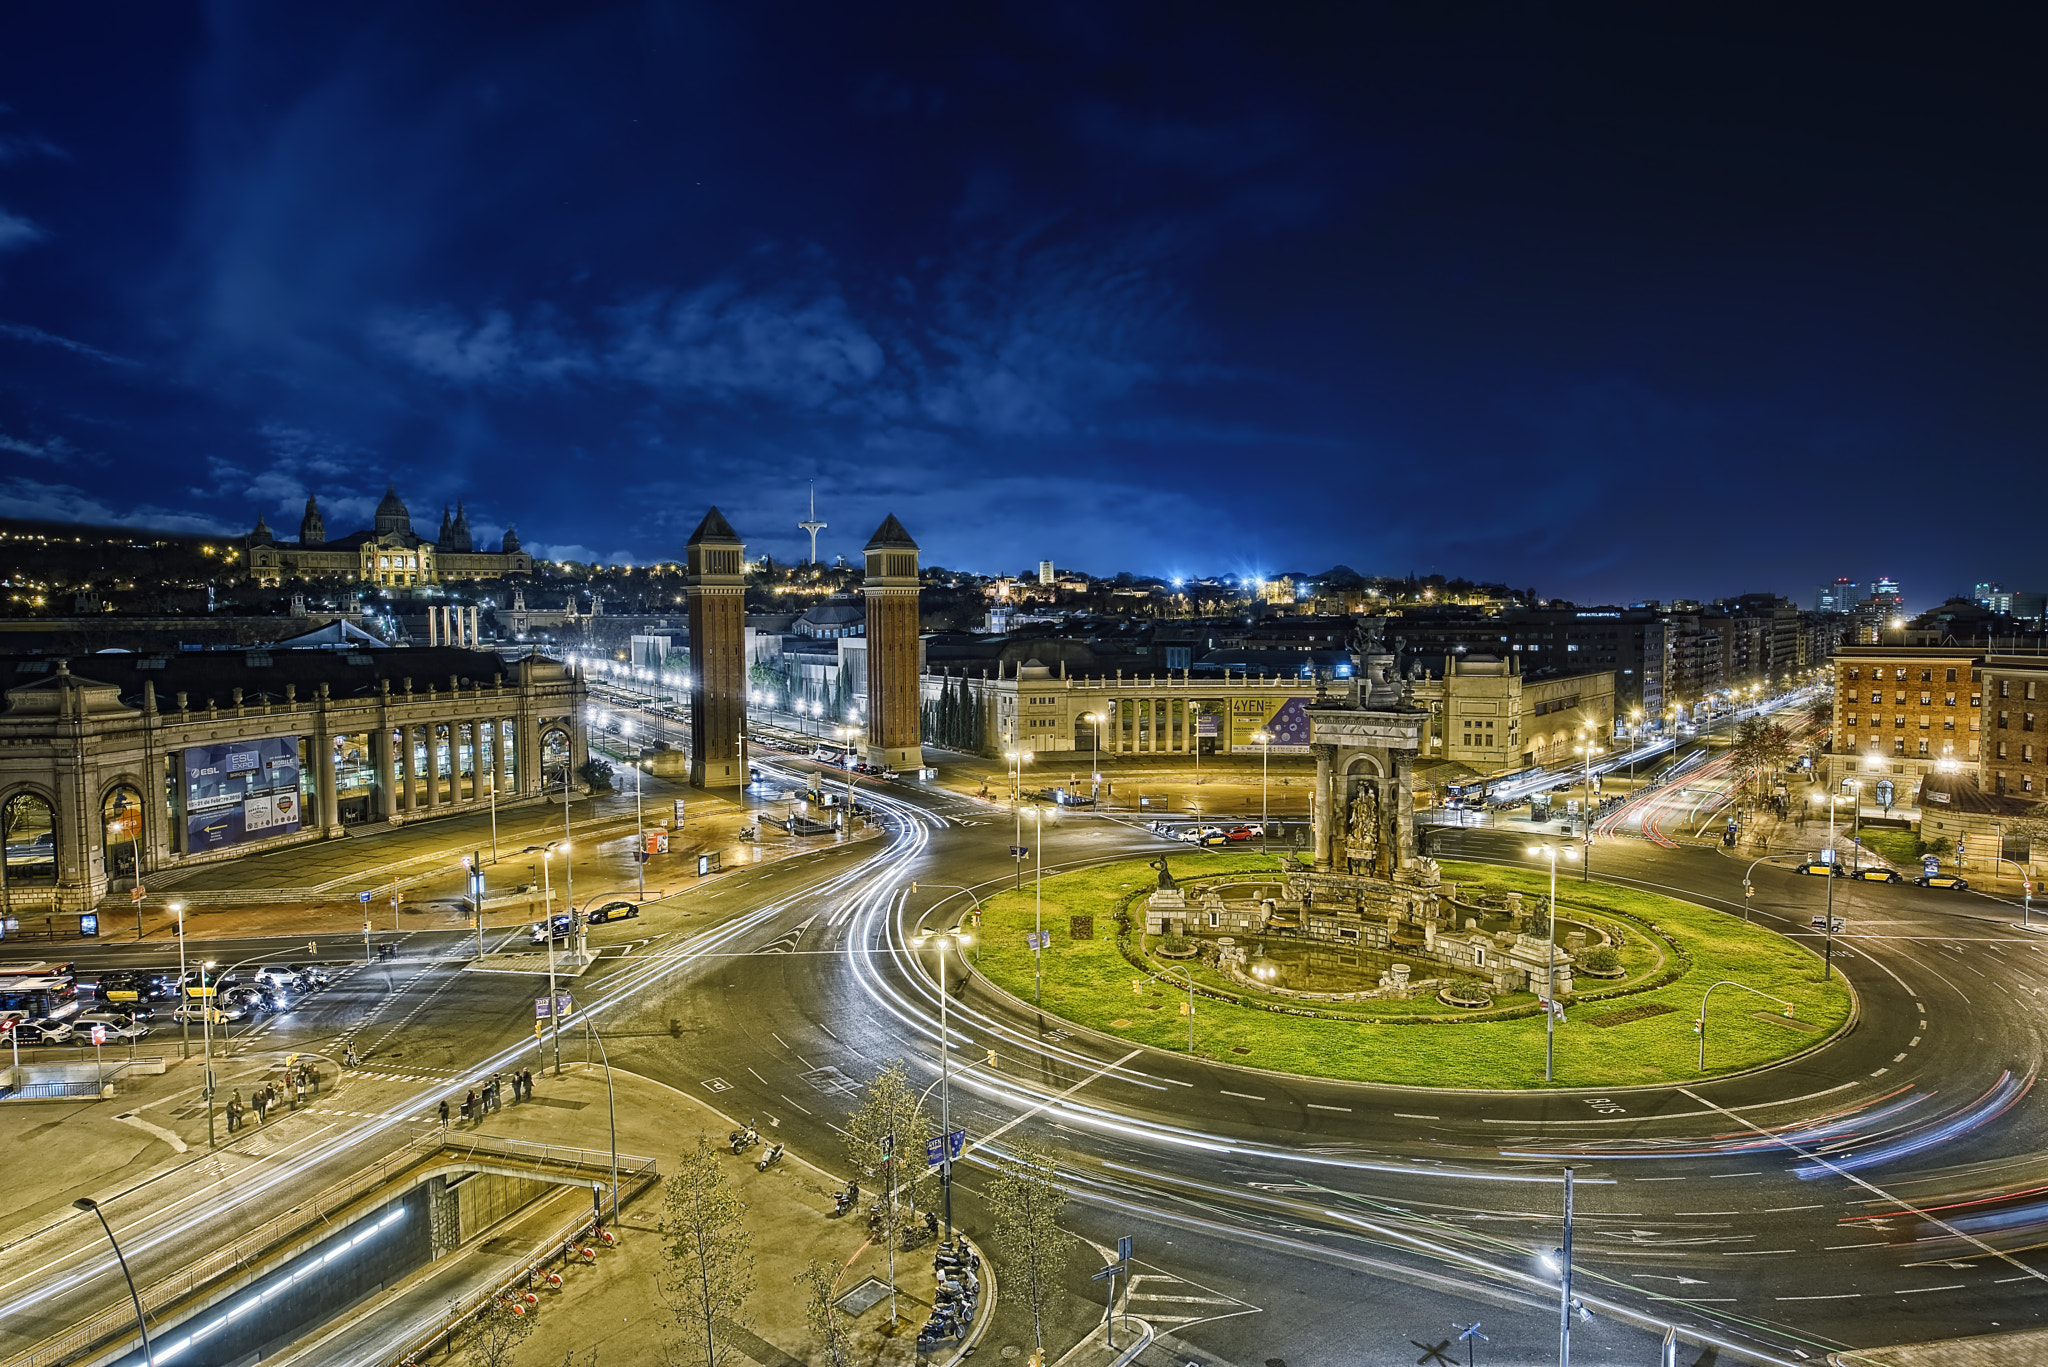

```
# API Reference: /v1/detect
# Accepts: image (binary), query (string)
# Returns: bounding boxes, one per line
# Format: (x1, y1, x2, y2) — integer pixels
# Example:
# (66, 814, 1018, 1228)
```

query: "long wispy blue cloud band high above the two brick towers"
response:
(371, 234, 1187, 437)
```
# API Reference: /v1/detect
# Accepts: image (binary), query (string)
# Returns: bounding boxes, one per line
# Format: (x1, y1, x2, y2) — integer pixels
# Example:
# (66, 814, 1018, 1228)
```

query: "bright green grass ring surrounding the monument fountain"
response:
(975, 851, 1849, 1088)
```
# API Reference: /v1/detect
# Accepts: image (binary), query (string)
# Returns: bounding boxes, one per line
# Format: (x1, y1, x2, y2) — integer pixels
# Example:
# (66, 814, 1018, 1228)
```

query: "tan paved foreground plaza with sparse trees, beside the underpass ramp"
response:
(385, 1064, 995, 1367)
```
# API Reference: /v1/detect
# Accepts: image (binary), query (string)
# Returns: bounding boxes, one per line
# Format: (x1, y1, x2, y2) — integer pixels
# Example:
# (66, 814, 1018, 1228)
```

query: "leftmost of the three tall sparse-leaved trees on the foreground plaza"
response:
(657, 1135, 754, 1367)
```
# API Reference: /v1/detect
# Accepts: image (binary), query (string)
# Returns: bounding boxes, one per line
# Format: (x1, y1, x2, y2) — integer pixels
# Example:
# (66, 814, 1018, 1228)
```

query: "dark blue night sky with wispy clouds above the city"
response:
(0, 2, 2048, 605)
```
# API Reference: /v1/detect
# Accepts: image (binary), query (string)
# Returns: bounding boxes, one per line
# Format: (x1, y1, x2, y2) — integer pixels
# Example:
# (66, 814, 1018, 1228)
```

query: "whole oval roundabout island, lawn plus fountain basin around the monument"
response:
(973, 851, 1853, 1088)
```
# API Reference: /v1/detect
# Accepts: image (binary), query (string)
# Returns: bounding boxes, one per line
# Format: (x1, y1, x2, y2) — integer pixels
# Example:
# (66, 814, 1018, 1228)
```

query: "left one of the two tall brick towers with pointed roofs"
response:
(684, 508, 748, 789)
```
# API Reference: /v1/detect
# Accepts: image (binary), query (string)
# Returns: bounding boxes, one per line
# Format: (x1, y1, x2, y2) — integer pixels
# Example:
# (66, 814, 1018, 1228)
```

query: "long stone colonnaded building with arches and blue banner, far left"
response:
(0, 646, 588, 918)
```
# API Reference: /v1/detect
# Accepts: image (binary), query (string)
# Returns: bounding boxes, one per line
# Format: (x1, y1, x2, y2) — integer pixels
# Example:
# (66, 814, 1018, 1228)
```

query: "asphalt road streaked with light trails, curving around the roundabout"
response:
(16, 754, 2048, 1367)
